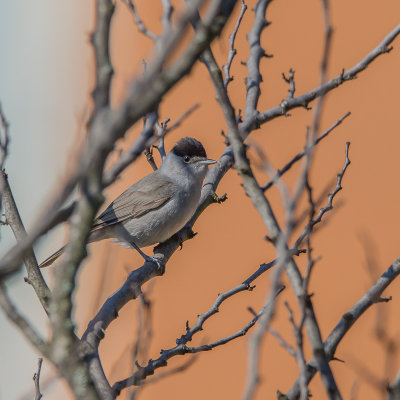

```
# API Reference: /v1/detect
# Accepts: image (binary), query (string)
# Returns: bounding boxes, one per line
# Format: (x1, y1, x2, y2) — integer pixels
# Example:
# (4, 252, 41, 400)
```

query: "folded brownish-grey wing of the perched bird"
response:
(92, 171, 176, 232)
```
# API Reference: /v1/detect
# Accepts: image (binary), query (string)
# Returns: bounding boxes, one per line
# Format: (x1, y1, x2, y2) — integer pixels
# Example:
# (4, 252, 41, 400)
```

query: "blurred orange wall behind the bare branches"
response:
(69, 0, 400, 400)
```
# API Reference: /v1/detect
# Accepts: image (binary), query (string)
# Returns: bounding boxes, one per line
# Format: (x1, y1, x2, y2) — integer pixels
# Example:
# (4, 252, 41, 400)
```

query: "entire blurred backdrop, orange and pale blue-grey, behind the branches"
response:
(0, 0, 400, 400)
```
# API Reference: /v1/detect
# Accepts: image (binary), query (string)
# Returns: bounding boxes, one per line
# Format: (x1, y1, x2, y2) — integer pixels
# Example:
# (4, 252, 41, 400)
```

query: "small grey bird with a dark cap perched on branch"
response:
(39, 137, 216, 268)
